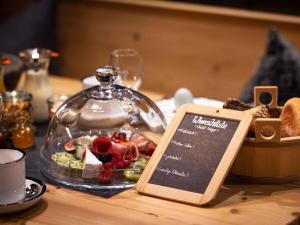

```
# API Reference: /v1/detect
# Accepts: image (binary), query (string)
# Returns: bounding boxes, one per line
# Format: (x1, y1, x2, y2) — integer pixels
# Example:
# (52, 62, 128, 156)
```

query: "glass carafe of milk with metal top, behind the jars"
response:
(19, 48, 53, 122)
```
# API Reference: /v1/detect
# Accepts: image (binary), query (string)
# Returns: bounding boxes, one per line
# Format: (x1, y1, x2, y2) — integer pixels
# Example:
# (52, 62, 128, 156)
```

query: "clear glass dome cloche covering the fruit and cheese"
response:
(41, 66, 166, 190)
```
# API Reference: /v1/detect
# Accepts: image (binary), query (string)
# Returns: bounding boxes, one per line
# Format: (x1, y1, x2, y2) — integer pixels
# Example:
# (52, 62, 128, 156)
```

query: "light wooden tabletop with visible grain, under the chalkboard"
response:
(0, 78, 300, 225)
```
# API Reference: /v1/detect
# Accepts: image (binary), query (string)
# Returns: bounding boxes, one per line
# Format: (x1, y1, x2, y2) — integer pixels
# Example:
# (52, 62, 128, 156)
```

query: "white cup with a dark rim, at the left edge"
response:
(0, 149, 26, 205)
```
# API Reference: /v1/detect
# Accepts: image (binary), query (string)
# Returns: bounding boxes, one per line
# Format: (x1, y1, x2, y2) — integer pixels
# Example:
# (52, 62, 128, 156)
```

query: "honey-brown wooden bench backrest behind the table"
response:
(59, 0, 300, 100)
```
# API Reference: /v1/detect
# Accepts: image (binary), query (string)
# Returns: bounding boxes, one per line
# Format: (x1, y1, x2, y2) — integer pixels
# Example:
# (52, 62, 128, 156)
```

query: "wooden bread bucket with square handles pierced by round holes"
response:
(230, 87, 300, 183)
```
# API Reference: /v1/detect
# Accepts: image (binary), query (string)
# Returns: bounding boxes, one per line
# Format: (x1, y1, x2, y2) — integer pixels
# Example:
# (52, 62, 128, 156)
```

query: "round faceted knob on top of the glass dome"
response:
(96, 66, 117, 89)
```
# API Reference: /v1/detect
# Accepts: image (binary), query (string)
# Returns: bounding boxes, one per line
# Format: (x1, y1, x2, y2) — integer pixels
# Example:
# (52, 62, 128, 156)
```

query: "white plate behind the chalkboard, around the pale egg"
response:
(155, 98, 224, 124)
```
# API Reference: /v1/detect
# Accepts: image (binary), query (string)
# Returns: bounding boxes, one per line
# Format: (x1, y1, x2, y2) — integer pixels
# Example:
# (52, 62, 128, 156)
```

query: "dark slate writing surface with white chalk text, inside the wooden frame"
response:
(149, 113, 240, 193)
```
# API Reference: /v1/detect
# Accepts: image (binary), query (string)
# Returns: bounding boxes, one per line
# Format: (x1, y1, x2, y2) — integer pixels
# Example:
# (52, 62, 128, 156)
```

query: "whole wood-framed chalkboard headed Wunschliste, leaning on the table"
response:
(137, 105, 252, 205)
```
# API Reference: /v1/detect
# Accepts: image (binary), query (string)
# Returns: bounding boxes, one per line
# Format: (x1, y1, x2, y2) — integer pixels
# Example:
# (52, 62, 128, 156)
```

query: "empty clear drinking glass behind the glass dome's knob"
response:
(109, 49, 144, 91)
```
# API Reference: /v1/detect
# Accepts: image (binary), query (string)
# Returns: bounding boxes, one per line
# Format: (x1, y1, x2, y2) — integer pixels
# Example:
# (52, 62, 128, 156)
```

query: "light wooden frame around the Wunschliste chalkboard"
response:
(136, 104, 253, 205)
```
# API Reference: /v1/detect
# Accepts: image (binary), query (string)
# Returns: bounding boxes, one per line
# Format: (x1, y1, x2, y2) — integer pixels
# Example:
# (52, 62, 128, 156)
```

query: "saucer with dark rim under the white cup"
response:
(0, 177, 46, 214)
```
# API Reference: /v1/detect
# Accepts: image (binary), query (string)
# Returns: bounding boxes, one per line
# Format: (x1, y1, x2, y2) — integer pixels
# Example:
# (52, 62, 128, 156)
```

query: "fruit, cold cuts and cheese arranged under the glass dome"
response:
(51, 132, 156, 184)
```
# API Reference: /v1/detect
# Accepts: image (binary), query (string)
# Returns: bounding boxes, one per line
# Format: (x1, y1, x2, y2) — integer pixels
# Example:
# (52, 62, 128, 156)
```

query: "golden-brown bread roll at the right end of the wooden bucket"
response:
(280, 98, 300, 137)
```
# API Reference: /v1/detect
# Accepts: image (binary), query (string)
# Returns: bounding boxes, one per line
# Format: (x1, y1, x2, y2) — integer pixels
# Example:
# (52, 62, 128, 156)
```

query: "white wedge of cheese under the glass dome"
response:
(82, 149, 102, 179)
